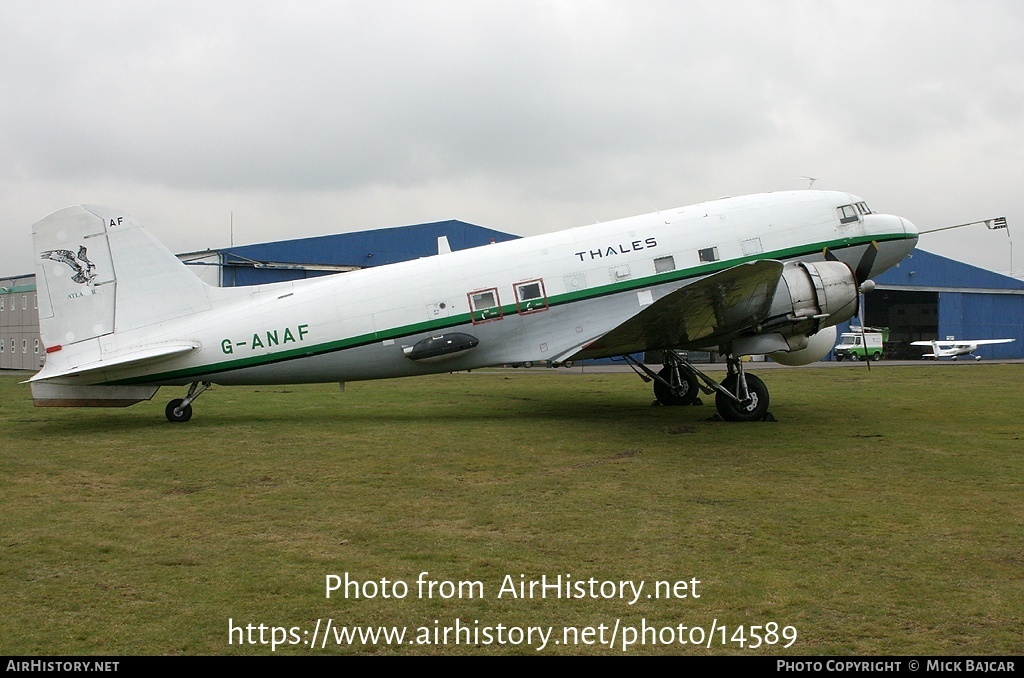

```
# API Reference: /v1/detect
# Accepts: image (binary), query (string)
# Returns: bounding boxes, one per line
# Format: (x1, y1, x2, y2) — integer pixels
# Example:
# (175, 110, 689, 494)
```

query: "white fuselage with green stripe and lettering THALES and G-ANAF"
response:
(34, 190, 916, 393)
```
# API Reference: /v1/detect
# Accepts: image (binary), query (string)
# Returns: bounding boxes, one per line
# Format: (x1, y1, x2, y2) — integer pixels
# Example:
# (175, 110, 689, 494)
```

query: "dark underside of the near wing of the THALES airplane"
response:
(564, 259, 782, 361)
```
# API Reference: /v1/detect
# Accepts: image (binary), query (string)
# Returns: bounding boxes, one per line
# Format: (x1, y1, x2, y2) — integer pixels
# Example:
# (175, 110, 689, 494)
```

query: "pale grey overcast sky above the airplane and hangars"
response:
(0, 0, 1024, 276)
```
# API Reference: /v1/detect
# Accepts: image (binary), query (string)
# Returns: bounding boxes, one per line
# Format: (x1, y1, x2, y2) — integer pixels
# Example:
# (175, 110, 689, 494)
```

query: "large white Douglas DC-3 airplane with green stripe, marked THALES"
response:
(30, 190, 918, 422)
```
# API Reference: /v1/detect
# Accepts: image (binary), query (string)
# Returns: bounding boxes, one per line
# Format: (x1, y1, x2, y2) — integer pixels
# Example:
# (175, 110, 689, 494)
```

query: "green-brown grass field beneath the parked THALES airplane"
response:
(0, 364, 1024, 654)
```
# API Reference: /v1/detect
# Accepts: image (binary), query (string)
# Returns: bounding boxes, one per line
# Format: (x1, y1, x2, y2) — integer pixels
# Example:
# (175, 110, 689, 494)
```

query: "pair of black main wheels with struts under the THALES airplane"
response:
(624, 350, 769, 421)
